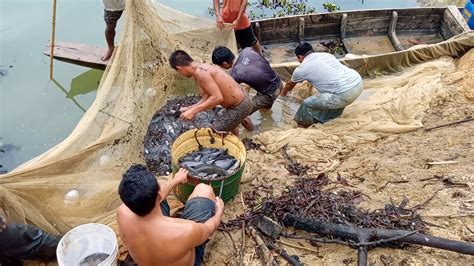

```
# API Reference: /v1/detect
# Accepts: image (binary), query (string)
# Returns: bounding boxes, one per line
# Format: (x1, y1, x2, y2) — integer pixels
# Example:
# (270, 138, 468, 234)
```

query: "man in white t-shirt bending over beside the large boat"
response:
(281, 42, 362, 127)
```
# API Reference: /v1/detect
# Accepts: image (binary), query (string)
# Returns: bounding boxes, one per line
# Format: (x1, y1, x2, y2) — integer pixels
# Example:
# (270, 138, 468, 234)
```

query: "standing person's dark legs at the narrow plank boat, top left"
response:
(101, 0, 125, 61)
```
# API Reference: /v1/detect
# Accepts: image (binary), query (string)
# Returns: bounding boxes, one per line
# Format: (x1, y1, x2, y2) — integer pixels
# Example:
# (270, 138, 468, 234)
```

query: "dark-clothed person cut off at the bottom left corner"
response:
(0, 215, 61, 265)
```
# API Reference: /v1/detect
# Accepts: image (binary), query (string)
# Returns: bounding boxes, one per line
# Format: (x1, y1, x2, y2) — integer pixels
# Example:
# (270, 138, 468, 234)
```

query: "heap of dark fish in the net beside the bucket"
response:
(144, 96, 219, 175)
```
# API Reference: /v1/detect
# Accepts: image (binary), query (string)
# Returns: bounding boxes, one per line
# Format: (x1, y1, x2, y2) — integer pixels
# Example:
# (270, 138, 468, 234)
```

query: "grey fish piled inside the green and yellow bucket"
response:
(179, 148, 240, 180)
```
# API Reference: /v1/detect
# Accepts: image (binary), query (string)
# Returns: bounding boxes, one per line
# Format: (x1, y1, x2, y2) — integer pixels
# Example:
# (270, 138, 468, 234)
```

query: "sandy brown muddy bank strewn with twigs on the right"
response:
(206, 51, 474, 265)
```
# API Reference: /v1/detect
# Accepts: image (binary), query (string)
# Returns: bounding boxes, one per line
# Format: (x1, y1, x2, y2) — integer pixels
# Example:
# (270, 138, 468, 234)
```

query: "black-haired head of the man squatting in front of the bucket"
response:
(119, 164, 160, 216)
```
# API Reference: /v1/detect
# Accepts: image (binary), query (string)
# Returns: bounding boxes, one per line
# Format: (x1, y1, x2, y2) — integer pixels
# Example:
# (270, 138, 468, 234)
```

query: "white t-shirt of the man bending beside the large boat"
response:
(291, 53, 362, 93)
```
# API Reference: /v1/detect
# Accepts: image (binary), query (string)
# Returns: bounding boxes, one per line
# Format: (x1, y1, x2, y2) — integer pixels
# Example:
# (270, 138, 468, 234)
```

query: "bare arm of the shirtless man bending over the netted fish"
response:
(181, 69, 224, 120)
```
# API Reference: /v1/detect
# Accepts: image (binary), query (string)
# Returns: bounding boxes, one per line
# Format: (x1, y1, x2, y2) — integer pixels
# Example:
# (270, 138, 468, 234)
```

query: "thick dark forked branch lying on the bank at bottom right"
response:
(282, 213, 474, 265)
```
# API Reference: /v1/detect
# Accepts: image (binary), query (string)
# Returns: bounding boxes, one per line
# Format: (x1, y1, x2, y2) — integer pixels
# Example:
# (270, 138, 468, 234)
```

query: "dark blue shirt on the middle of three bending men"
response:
(229, 47, 281, 95)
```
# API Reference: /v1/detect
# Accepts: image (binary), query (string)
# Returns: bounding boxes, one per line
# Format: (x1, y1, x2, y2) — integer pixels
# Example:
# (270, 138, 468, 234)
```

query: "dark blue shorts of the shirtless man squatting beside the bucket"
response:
(160, 197, 216, 266)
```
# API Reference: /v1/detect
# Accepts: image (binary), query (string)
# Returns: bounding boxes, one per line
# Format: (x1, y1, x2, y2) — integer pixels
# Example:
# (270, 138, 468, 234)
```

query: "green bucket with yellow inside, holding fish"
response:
(171, 128, 247, 203)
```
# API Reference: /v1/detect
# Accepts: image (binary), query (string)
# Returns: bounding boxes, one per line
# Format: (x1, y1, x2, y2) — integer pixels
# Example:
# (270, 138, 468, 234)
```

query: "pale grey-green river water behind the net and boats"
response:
(0, 0, 464, 172)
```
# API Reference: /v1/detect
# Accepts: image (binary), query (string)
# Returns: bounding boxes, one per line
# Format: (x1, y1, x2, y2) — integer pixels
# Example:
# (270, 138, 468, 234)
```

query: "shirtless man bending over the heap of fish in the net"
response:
(169, 50, 253, 136)
